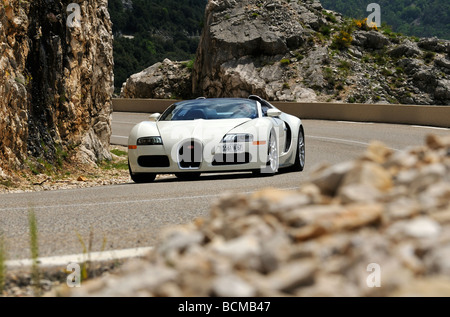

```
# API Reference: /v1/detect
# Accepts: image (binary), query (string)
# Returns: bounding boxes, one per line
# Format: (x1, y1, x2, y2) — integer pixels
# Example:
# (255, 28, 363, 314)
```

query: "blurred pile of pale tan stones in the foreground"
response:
(63, 135, 450, 296)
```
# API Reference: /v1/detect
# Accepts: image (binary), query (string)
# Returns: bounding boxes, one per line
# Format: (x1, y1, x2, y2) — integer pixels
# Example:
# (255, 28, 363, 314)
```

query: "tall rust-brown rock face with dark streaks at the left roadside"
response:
(0, 0, 113, 175)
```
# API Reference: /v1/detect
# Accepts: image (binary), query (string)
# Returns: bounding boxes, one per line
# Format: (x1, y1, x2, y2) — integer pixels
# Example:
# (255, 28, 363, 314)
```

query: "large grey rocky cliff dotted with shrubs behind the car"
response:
(122, 0, 450, 105)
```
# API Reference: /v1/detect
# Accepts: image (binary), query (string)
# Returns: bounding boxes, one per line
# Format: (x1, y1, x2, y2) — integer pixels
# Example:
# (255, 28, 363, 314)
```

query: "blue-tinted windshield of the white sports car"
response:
(159, 98, 258, 121)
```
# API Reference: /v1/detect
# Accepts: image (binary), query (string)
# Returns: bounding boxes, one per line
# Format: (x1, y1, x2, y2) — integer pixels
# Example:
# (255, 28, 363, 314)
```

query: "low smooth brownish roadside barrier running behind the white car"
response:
(112, 98, 450, 128)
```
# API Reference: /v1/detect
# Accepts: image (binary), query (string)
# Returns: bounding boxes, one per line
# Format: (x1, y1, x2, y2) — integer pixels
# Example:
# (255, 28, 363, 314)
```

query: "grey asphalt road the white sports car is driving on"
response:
(0, 113, 450, 260)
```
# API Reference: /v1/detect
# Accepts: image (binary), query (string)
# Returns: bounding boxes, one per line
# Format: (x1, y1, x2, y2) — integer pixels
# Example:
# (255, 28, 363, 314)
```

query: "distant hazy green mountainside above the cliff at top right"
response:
(320, 0, 450, 40)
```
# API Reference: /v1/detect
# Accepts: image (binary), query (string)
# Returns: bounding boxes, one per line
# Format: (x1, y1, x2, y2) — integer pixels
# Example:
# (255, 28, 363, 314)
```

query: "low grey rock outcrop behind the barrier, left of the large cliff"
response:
(120, 58, 192, 99)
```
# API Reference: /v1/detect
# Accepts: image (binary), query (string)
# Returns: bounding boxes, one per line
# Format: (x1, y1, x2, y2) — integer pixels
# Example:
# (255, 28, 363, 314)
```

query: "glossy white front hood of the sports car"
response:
(157, 118, 251, 145)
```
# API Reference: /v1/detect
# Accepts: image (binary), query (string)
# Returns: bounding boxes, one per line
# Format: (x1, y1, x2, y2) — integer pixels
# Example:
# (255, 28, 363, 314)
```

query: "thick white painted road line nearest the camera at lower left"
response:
(5, 247, 153, 268)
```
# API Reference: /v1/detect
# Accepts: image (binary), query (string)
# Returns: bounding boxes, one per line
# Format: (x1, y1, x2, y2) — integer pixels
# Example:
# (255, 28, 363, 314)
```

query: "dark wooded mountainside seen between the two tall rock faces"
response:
(108, 0, 207, 92)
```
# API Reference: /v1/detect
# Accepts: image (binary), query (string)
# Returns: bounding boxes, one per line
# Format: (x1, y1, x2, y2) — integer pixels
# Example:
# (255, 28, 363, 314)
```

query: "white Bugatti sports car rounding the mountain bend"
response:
(128, 95, 305, 183)
